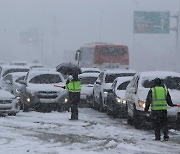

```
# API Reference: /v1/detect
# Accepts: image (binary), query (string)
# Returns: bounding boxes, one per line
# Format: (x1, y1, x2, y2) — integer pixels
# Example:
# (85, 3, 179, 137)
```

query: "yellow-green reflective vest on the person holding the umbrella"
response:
(66, 81, 81, 92)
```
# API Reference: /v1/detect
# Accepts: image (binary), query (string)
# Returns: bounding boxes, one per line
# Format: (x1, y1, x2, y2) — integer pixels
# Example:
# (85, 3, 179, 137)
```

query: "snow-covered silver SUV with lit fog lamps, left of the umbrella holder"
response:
(20, 68, 69, 111)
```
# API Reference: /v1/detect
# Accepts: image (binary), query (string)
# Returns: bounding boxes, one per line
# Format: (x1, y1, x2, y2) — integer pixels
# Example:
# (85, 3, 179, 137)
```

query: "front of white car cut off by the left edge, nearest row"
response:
(0, 87, 20, 116)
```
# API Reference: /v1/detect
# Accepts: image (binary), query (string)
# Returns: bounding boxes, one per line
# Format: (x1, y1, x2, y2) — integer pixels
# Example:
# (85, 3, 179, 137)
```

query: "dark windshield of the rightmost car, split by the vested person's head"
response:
(142, 76, 180, 90)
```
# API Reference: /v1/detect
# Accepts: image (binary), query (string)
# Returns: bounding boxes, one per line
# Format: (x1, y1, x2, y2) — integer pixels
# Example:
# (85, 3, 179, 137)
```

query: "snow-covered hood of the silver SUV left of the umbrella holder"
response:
(27, 83, 65, 92)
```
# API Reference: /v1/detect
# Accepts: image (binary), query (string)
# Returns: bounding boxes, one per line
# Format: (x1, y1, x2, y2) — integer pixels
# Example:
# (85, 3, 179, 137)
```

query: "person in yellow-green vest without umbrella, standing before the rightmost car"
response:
(144, 78, 180, 141)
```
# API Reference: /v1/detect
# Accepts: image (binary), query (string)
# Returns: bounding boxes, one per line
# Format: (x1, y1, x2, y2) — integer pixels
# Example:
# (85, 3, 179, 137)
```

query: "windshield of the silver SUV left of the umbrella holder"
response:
(29, 74, 62, 84)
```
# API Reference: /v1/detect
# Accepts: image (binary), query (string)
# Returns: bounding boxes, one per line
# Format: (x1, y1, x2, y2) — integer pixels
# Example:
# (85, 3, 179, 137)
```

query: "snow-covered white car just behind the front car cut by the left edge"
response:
(2, 72, 27, 96)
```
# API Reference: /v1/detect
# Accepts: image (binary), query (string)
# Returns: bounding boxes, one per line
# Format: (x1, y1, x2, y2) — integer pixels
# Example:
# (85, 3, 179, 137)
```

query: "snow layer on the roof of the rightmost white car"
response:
(139, 71, 180, 78)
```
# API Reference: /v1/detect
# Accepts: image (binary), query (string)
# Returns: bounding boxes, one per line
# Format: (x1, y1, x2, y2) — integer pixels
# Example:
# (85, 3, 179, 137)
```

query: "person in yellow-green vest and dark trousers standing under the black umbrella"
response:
(66, 74, 81, 120)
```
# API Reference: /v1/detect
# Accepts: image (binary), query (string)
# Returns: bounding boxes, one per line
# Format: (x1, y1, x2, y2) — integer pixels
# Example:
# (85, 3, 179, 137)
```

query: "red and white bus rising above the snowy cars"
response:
(75, 43, 129, 69)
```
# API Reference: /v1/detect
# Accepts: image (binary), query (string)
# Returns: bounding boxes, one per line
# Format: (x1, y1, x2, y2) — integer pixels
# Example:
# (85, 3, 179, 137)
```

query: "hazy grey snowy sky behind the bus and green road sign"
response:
(0, 0, 180, 71)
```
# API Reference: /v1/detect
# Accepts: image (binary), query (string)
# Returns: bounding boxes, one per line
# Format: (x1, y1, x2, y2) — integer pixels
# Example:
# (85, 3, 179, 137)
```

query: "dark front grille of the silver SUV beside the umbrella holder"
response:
(37, 91, 58, 99)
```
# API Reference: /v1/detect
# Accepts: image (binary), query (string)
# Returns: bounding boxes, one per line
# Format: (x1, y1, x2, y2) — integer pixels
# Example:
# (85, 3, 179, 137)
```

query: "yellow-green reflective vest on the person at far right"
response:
(151, 86, 167, 111)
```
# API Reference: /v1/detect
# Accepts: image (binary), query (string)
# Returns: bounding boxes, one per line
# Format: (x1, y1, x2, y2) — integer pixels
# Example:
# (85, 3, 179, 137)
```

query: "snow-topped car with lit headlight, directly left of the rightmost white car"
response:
(106, 76, 133, 118)
